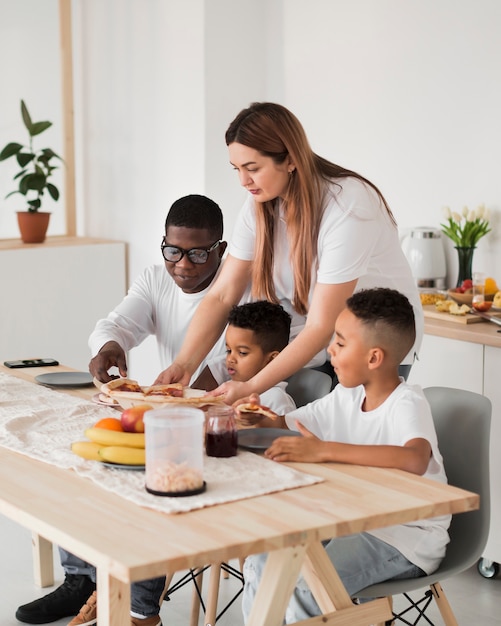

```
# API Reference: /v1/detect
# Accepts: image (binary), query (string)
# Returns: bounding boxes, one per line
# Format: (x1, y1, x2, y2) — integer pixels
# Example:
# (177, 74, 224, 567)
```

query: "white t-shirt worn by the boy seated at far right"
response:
(286, 381, 451, 573)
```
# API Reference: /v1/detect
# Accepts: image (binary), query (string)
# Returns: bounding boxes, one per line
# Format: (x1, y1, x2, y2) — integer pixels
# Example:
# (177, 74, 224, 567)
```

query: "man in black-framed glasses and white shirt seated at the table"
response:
(16, 195, 227, 626)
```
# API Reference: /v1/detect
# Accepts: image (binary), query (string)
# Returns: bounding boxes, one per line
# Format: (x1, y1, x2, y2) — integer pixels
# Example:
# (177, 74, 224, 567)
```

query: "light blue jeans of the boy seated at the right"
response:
(242, 533, 425, 624)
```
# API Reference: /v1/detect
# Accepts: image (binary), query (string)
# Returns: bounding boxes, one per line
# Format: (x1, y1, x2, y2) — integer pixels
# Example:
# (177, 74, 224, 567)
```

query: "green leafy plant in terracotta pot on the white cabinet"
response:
(0, 100, 62, 243)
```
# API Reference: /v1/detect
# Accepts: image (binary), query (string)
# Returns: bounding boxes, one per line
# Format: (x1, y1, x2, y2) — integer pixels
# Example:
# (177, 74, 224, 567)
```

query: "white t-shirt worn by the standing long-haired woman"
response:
(229, 177, 424, 365)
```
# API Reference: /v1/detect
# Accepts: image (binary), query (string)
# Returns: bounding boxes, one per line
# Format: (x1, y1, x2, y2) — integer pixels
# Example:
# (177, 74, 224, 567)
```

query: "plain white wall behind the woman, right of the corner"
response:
(284, 0, 501, 284)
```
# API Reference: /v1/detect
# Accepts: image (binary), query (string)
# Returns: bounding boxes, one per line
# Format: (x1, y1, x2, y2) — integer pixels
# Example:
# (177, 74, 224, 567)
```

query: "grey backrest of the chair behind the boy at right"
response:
(424, 387, 492, 575)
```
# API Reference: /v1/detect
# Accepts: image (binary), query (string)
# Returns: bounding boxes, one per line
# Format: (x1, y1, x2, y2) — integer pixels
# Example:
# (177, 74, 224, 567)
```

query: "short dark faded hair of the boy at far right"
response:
(346, 287, 416, 364)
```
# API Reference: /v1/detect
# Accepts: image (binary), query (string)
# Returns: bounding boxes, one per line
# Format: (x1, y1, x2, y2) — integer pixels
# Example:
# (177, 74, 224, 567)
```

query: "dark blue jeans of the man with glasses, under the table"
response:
(59, 548, 165, 617)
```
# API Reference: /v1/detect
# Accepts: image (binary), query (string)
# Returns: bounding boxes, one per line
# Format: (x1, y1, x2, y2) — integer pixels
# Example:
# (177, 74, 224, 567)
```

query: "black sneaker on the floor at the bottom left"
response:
(16, 574, 96, 624)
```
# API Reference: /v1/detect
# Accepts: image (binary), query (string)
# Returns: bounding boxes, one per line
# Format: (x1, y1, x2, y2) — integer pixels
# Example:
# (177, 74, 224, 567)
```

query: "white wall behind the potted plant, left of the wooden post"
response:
(0, 0, 65, 239)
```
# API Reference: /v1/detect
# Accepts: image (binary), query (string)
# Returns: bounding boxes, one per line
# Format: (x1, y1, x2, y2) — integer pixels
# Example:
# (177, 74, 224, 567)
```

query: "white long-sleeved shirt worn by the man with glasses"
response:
(89, 265, 226, 381)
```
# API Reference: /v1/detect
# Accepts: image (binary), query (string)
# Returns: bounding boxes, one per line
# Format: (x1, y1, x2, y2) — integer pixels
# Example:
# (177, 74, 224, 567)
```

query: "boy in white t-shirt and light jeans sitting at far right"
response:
(237, 288, 450, 624)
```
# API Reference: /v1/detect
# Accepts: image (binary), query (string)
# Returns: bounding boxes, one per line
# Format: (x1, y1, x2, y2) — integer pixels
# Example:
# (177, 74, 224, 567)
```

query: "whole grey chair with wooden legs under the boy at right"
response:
(357, 387, 492, 626)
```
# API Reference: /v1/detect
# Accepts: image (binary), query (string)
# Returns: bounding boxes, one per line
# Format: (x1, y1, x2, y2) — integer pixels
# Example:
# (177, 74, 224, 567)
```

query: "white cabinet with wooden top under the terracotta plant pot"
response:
(0, 237, 126, 371)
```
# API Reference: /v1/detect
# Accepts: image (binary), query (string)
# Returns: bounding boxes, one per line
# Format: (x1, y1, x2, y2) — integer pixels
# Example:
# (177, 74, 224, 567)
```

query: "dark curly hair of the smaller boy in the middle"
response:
(228, 300, 291, 354)
